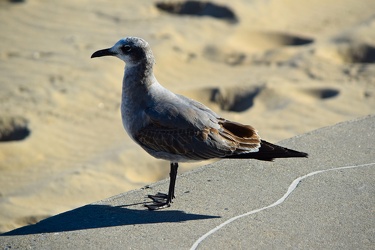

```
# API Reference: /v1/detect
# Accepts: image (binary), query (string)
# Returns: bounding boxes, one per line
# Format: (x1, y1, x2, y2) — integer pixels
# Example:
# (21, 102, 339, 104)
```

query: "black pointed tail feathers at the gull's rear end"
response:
(224, 140, 308, 161)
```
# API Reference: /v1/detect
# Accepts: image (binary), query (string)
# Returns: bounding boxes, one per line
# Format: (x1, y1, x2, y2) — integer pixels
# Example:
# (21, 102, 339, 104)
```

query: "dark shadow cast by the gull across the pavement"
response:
(2, 204, 220, 236)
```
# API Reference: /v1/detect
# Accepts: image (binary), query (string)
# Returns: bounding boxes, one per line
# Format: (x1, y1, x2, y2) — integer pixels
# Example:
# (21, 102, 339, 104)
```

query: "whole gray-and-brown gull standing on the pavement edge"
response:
(91, 37, 308, 210)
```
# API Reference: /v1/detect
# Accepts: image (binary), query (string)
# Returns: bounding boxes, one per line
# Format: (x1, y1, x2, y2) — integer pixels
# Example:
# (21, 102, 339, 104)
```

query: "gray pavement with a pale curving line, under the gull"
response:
(0, 116, 375, 249)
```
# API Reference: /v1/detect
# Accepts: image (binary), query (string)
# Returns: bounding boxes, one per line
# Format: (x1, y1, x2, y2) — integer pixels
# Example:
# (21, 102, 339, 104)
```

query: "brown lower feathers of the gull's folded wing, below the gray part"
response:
(135, 120, 260, 160)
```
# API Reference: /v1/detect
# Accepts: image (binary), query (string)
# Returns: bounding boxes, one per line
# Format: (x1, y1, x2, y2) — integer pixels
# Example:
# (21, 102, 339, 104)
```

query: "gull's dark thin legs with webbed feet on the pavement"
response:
(145, 162, 178, 210)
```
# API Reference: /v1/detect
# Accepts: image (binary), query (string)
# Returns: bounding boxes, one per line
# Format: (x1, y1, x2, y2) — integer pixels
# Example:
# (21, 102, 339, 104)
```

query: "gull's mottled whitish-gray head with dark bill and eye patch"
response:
(91, 37, 154, 66)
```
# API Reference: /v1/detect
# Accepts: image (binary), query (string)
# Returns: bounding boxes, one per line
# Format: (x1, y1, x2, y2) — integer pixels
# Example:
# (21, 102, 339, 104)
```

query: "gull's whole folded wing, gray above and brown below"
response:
(135, 94, 260, 160)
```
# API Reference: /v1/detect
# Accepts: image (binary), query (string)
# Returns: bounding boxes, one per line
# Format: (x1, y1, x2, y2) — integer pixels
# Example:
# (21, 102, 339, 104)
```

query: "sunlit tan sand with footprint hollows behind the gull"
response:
(0, 0, 375, 232)
